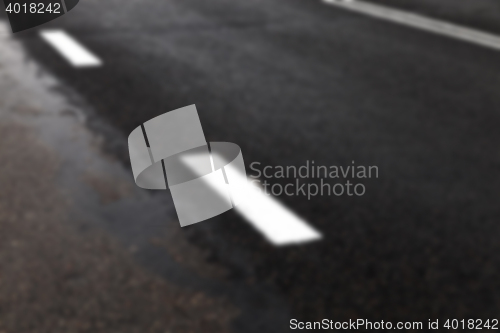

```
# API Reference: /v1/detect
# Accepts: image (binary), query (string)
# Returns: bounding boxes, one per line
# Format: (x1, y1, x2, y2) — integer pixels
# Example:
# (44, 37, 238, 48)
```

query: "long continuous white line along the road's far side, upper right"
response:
(323, 0, 500, 51)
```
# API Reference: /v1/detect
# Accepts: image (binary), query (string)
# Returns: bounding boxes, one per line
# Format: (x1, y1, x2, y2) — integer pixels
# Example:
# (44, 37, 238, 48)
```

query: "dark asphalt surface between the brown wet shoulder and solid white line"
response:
(3, 0, 500, 331)
